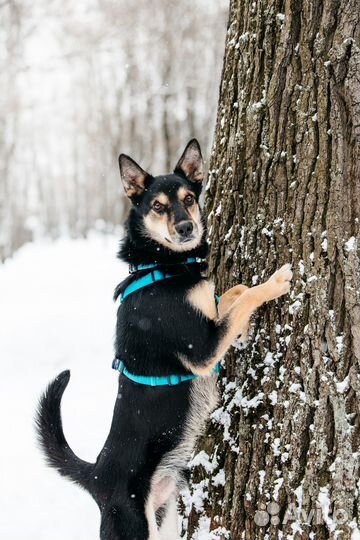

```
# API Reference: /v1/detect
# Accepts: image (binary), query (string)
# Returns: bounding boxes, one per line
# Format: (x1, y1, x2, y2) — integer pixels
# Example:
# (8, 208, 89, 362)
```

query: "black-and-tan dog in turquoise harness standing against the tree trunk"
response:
(36, 139, 292, 540)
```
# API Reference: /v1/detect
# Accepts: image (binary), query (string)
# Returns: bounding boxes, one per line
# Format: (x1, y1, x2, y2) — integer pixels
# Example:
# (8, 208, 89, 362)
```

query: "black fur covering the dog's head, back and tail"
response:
(37, 140, 225, 540)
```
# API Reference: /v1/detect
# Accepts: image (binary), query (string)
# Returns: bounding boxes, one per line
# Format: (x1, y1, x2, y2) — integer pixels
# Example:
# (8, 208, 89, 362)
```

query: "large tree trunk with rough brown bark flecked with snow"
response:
(186, 0, 360, 540)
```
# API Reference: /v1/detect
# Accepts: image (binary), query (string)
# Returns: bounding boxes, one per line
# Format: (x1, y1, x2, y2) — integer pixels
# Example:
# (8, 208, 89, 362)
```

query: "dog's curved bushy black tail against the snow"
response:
(35, 371, 94, 489)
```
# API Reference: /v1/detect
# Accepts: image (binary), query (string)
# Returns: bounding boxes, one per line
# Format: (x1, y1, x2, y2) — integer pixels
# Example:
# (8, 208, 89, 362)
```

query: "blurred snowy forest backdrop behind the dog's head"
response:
(0, 0, 228, 261)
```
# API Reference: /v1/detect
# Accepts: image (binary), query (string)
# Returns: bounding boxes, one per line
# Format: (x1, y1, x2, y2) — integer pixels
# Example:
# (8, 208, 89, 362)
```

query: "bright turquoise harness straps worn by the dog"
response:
(112, 258, 220, 386)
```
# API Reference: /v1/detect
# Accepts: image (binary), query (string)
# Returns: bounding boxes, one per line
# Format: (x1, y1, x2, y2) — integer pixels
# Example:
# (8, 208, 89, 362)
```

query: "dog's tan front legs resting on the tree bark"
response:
(180, 264, 292, 376)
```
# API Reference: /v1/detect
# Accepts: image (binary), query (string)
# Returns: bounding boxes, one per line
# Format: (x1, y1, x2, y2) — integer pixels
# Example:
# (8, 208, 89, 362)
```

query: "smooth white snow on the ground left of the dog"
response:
(0, 235, 127, 540)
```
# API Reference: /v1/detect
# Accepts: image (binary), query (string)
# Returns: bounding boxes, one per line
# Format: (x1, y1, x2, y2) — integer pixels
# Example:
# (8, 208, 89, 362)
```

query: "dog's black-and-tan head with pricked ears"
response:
(119, 139, 204, 252)
